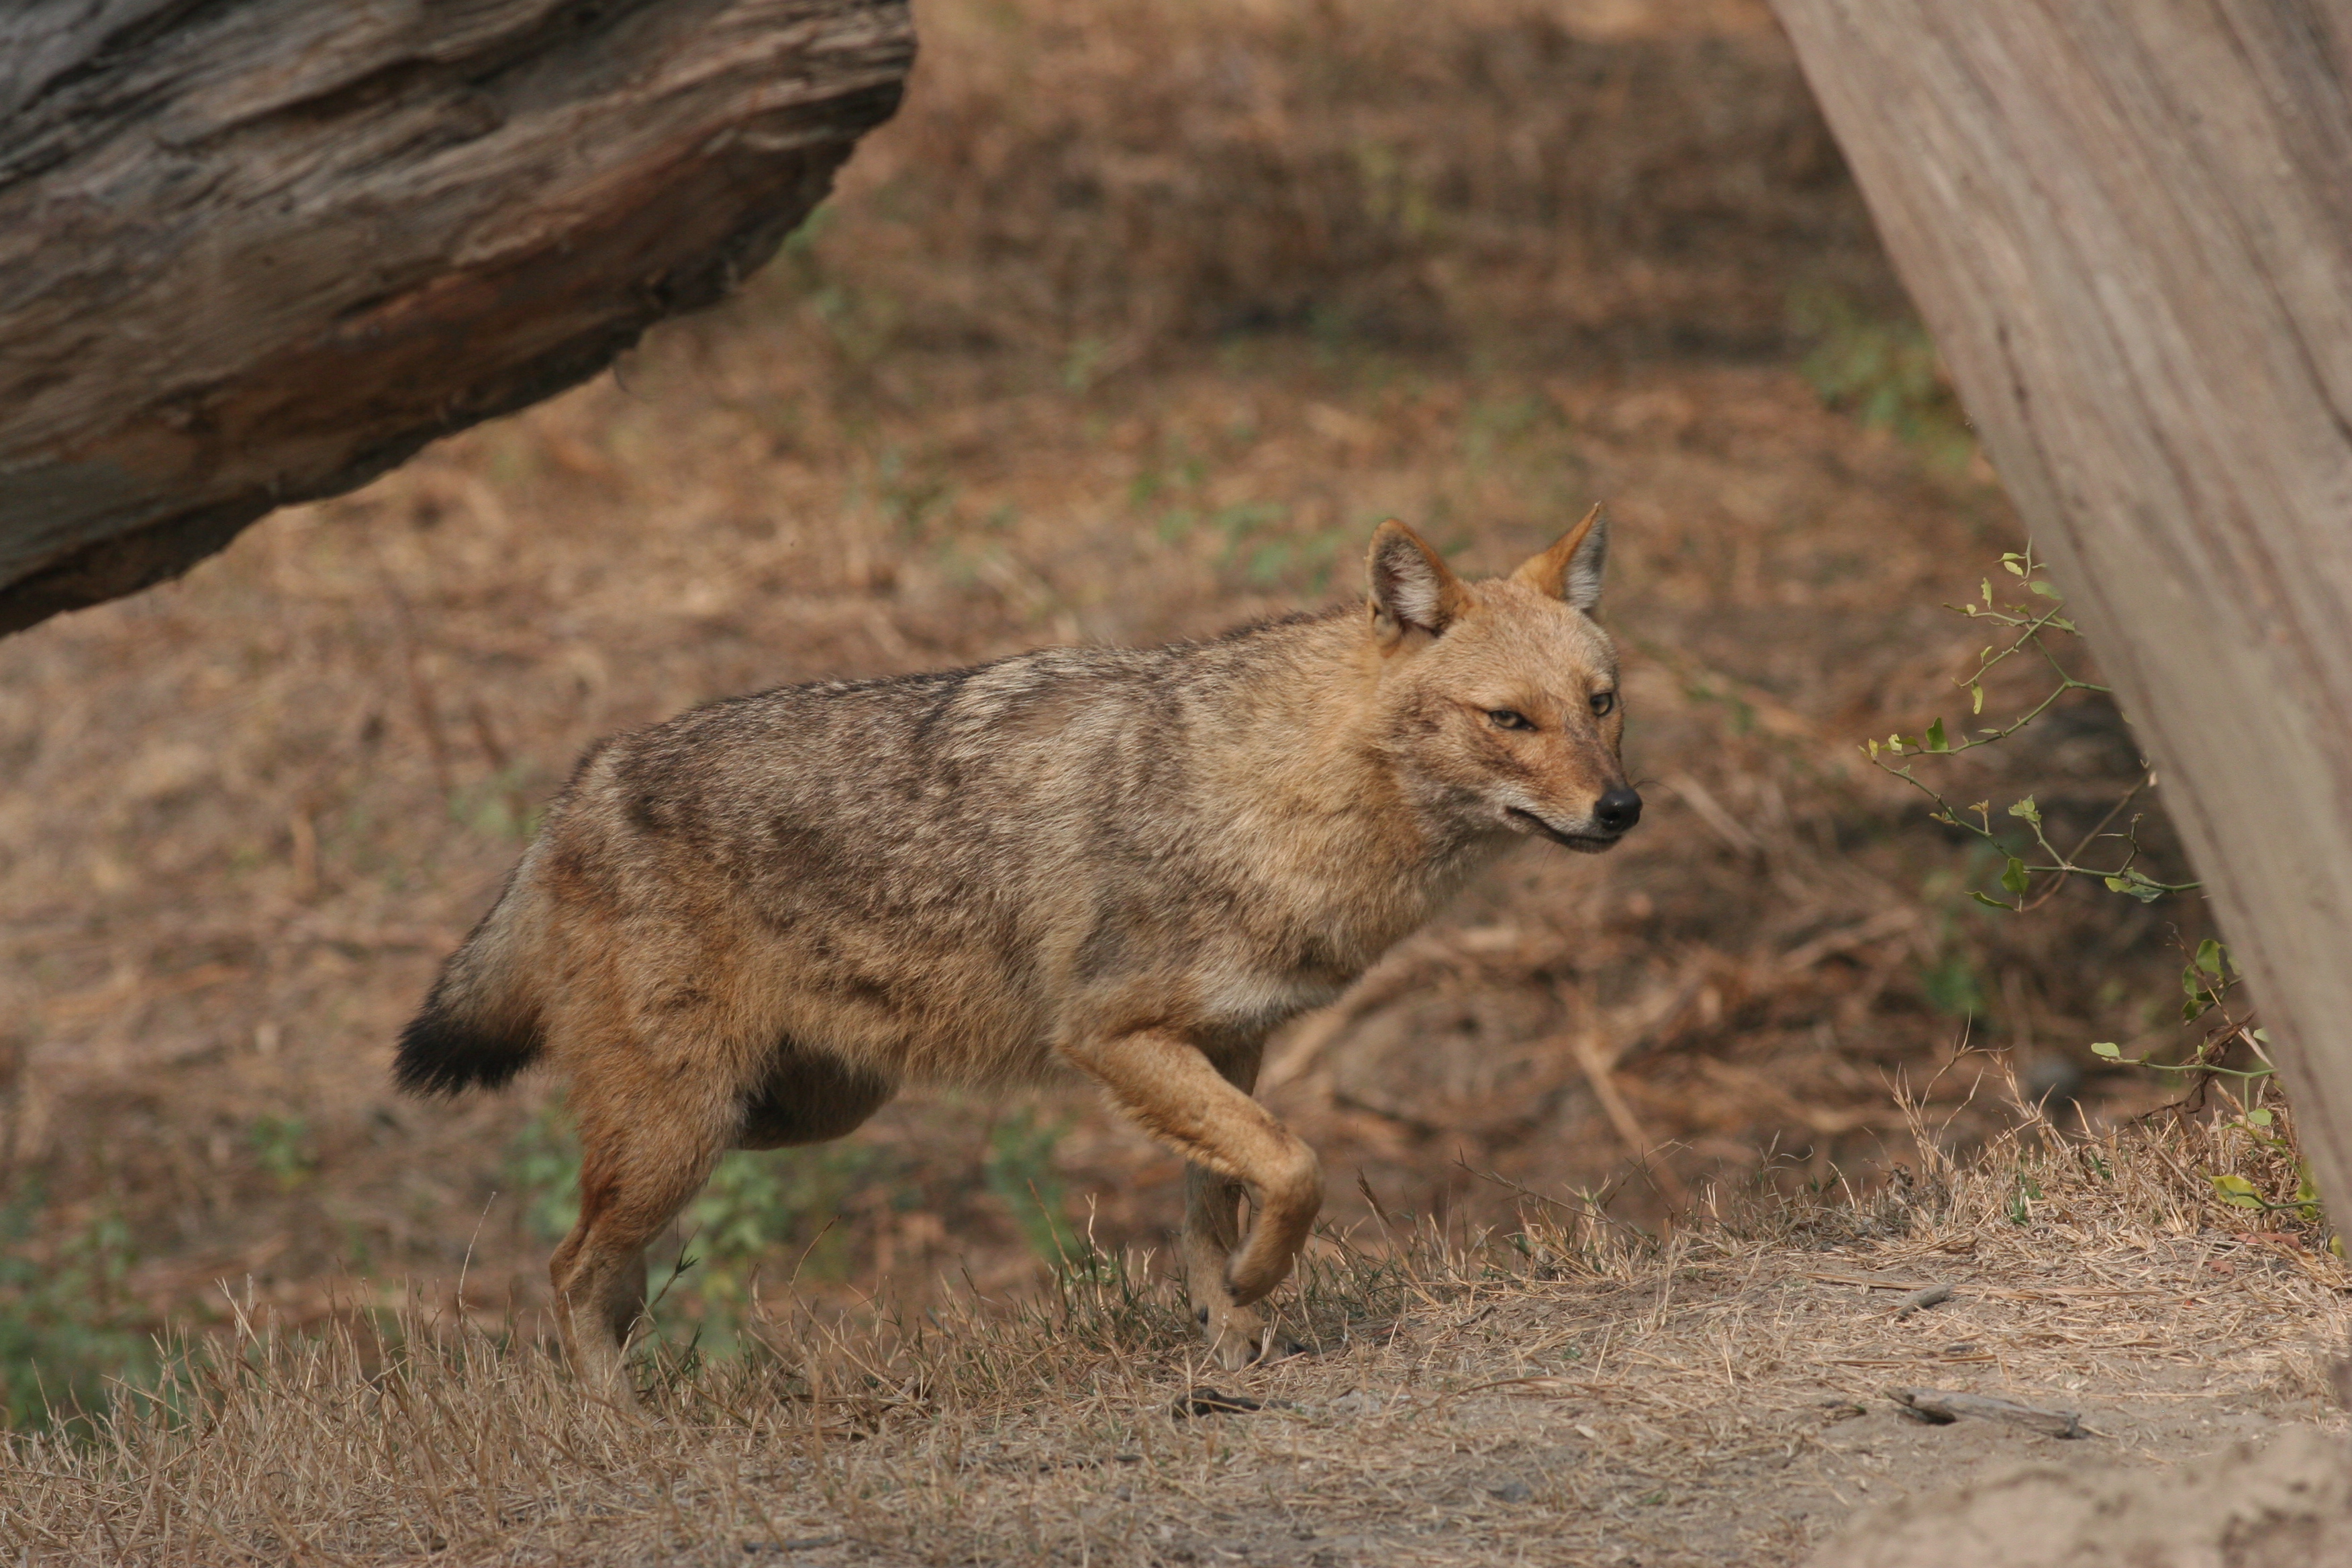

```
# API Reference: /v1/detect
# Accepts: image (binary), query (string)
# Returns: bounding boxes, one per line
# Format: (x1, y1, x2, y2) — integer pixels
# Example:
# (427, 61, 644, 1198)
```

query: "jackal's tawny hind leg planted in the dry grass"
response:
(548, 1058, 738, 1406)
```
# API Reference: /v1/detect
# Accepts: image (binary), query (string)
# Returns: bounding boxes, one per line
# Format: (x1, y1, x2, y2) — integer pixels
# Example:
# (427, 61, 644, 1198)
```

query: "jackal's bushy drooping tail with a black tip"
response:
(393, 856, 546, 1095)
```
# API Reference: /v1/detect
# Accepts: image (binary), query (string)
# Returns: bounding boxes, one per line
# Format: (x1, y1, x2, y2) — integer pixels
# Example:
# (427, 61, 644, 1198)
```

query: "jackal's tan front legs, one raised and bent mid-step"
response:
(1073, 1030, 1322, 1368)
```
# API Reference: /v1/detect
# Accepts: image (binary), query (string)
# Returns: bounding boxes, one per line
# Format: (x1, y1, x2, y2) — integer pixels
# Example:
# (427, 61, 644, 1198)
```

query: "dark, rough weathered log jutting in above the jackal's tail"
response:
(0, 0, 915, 632)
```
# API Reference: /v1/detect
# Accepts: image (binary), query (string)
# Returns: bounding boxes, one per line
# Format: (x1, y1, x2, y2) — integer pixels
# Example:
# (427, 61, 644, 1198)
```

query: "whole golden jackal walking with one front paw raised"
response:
(395, 507, 1642, 1394)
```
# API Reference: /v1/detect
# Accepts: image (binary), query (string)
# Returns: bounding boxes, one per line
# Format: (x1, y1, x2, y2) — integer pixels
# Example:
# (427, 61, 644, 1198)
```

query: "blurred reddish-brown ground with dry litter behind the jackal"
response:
(0, 0, 2204, 1420)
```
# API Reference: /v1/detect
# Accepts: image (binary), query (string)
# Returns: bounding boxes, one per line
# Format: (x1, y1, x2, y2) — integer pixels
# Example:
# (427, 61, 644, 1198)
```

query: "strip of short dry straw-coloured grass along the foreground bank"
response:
(0, 1105, 2352, 1568)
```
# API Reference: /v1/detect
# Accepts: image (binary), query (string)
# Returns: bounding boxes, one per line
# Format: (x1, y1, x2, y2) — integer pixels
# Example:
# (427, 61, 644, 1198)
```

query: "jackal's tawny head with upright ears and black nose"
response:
(1369, 505, 1642, 853)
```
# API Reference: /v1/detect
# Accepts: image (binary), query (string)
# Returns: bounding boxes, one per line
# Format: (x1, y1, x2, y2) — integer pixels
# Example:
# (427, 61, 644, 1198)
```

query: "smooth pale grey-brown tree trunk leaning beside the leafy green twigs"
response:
(1776, 0, 2352, 1225)
